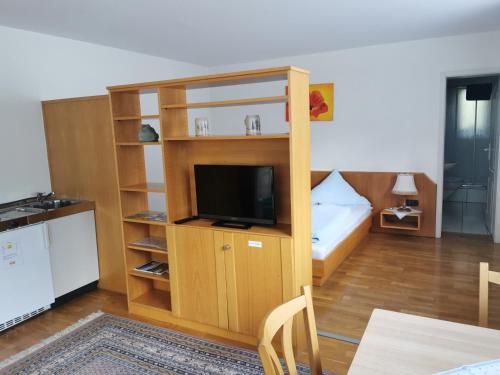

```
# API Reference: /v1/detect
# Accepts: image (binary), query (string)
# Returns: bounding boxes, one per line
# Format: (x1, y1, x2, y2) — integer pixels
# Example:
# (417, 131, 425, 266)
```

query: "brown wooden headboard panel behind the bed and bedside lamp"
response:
(311, 171, 437, 237)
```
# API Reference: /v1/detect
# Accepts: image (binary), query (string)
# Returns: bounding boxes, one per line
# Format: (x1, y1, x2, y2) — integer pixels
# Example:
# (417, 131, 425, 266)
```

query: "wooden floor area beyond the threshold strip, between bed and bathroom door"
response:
(314, 234, 500, 338)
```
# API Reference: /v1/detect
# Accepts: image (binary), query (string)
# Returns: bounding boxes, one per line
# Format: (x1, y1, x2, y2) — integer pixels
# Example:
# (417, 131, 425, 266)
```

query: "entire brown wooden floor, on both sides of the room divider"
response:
(0, 234, 500, 374)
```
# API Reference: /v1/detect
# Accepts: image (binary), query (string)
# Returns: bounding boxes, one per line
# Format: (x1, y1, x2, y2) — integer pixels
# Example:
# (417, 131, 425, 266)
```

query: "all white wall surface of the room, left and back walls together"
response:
(0, 27, 500, 239)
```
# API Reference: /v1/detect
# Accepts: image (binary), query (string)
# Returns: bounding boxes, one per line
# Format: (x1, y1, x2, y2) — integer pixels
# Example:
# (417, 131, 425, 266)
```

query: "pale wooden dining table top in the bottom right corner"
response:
(348, 307, 500, 375)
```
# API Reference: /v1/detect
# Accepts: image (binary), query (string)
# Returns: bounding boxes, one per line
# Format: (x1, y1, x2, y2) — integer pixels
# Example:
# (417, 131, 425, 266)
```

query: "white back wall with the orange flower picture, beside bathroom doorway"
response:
(209, 32, 500, 238)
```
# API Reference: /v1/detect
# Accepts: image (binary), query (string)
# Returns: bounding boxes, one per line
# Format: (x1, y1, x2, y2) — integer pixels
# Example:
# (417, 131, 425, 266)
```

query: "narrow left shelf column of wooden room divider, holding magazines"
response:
(109, 90, 171, 313)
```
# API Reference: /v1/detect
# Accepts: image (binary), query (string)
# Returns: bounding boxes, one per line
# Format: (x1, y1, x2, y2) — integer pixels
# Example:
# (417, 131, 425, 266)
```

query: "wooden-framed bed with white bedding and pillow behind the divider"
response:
(311, 171, 372, 286)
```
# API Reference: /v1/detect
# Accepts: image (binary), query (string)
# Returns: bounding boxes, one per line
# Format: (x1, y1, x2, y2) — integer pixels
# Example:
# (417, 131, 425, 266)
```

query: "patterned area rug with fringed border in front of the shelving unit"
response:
(0, 313, 318, 375)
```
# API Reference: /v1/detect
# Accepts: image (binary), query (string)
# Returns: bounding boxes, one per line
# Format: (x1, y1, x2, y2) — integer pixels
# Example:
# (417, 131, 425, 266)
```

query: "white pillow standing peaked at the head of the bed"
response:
(311, 170, 371, 206)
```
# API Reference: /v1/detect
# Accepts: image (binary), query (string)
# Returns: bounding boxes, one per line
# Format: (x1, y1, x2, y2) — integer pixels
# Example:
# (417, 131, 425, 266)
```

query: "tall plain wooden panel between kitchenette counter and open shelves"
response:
(42, 95, 123, 293)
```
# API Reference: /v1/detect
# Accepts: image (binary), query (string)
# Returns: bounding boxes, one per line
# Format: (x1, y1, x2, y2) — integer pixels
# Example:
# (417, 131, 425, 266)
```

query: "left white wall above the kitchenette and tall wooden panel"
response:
(0, 26, 206, 206)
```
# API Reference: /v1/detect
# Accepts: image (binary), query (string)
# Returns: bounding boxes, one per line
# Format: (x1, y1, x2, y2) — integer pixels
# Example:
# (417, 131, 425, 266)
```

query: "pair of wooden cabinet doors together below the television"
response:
(169, 225, 283, 336)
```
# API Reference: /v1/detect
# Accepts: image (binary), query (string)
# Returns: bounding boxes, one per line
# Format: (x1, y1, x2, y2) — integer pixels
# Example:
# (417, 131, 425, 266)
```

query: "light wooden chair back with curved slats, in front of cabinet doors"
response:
(259, 285, 322, 375)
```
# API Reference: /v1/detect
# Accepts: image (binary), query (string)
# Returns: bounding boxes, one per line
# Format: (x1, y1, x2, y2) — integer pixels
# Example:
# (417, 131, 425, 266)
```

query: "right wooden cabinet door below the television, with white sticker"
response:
(224, 233, 283, 336)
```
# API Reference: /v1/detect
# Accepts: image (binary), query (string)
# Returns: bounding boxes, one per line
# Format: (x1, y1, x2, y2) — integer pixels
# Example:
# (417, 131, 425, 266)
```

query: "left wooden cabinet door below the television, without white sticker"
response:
(169, 226, 219, 326)
